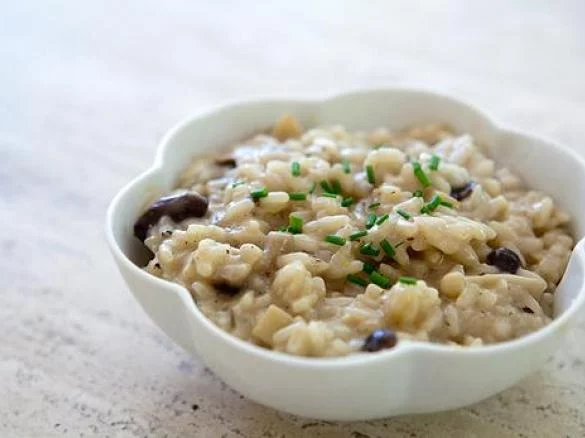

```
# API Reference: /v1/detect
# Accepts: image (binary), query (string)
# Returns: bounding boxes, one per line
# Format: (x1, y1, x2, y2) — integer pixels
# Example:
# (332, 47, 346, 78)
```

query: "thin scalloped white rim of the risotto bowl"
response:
(106, 87, 585, 368)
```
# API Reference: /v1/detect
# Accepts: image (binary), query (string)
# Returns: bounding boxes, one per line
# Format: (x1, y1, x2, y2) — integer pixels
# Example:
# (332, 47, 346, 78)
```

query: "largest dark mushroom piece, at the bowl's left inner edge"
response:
(134, 192, 208, 242)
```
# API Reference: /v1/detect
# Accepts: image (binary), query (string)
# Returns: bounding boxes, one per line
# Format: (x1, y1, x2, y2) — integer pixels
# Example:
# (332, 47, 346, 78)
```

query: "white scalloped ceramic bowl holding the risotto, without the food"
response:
(107, 89, 585, 420)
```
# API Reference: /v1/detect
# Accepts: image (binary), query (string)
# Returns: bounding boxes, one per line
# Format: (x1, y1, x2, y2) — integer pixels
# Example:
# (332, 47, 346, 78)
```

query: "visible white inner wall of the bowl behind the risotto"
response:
(112, 90, 585, 318)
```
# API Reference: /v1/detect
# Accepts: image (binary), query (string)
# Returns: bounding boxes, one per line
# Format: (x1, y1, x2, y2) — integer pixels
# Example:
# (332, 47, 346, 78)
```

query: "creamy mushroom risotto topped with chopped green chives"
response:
(134, 115, 573, 357)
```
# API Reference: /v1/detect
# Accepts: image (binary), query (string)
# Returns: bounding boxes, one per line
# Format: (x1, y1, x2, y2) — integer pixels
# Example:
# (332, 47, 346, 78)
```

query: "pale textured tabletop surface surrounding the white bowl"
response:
(0, 0, 585, 438)
